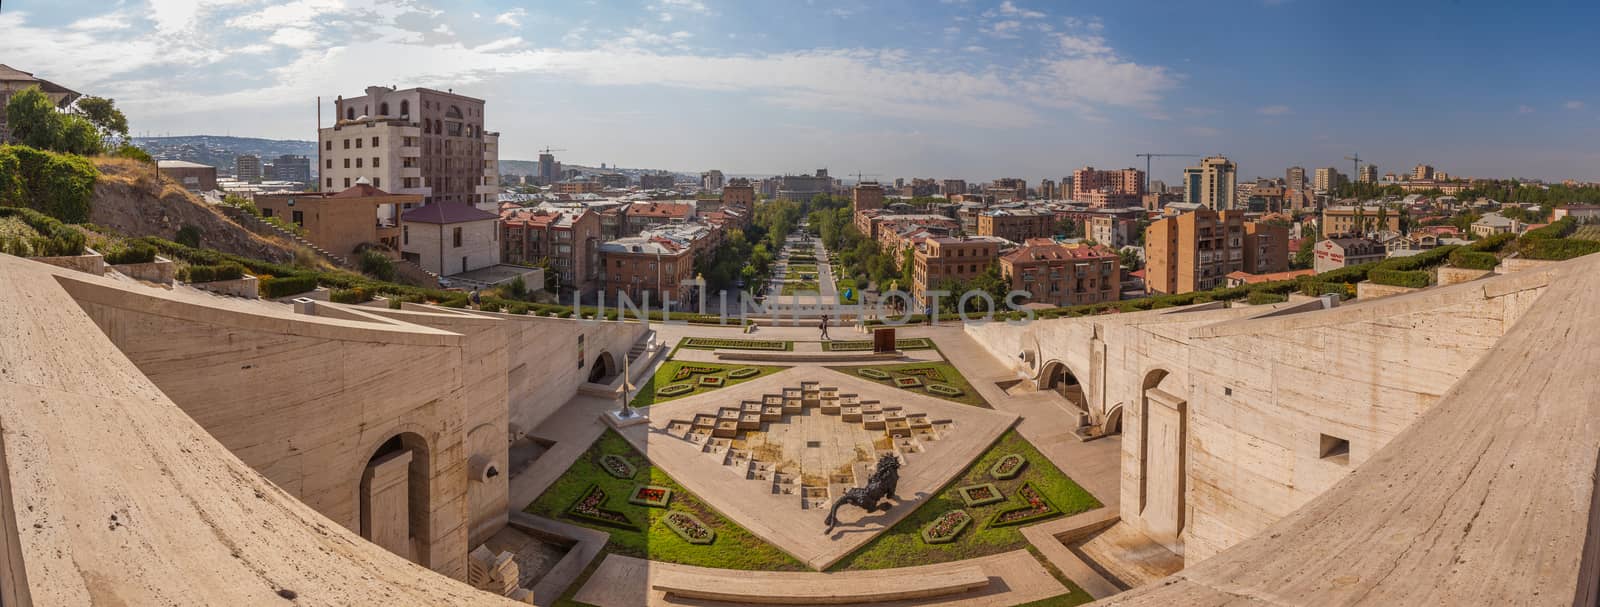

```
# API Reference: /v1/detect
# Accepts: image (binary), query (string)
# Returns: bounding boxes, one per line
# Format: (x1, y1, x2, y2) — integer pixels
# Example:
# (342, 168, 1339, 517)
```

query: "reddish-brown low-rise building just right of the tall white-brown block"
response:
(499, 203, 605, 296)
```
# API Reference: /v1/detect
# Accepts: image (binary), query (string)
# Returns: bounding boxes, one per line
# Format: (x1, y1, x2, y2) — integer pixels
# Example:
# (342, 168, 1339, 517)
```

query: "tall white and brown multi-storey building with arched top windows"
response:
(318, 86, 499, 205)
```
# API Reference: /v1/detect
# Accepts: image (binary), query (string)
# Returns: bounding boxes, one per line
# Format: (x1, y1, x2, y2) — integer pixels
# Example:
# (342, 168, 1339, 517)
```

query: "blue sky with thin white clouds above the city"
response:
(0, 0, 1600, 184)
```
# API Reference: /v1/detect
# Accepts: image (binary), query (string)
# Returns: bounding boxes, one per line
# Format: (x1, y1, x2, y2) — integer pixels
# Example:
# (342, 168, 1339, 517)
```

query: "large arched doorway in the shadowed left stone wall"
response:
(360, 432, 432, 567)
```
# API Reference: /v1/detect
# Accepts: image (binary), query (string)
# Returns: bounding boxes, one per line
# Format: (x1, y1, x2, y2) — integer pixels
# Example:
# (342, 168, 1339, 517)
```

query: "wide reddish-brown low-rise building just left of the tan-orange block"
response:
(1000, 239, 1122, 308)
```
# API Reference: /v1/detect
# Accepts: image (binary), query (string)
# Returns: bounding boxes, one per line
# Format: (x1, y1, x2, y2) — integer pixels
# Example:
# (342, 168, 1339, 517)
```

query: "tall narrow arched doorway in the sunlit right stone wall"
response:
(1139, 368, 1189, 551)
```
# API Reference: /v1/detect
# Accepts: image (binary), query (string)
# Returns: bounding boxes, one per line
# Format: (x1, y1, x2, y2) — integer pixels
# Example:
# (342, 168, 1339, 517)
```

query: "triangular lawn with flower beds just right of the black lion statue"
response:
(834, 431, 1101, 576)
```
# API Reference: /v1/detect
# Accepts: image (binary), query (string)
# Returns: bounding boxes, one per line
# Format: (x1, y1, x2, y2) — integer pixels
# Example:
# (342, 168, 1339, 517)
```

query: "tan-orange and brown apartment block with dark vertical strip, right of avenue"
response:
(1144, 207, 1245, 295)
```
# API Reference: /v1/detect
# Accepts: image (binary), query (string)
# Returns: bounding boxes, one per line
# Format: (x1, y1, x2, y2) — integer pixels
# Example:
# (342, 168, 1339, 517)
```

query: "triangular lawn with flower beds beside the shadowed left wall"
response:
(525, 429, 808, 605)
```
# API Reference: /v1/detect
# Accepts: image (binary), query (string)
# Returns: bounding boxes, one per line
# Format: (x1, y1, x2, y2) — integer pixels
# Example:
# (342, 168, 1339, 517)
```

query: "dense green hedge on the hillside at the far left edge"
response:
(0, 146, 99, 223)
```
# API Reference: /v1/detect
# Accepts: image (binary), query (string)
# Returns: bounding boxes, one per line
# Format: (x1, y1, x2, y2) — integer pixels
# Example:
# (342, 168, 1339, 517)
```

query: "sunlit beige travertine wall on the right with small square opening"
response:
(968, 272, 1547, 562)
